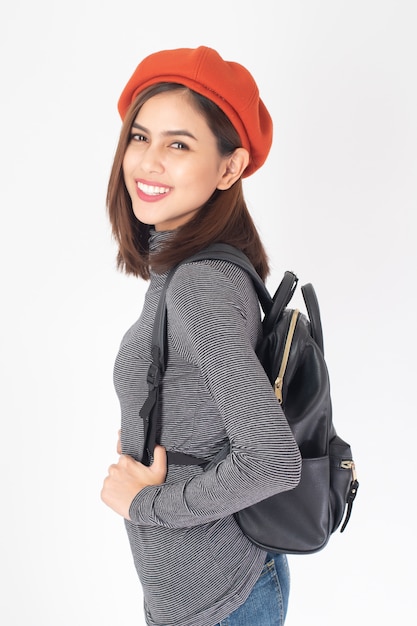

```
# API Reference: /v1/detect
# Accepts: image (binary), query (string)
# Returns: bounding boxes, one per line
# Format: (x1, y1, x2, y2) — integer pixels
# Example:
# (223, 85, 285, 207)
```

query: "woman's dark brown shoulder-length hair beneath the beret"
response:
(107, 83, 269, 280)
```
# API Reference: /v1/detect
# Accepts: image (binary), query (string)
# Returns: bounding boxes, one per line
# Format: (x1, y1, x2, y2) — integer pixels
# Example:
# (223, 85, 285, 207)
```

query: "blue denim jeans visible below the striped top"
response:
(217, 554, 290, 626)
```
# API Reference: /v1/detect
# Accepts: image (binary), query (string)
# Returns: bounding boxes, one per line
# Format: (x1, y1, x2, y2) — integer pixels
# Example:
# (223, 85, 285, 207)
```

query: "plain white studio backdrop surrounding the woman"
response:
(0, 0, 417, 626)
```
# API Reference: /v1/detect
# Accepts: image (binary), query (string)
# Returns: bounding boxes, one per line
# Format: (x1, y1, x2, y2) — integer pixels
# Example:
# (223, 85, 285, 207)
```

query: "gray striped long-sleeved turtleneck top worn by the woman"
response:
(114, 233, 301, 626)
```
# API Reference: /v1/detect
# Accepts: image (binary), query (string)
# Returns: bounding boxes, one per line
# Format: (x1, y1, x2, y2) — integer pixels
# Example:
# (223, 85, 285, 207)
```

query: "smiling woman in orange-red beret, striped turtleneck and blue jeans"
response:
(102, 47, 301, 626)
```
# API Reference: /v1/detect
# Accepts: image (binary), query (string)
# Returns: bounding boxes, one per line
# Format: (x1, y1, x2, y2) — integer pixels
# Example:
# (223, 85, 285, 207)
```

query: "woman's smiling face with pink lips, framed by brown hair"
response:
(123, 91, 230, 230)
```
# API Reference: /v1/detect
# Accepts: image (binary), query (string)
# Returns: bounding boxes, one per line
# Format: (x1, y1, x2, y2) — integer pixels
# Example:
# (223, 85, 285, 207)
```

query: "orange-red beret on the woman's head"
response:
(118, 46, 272, 177)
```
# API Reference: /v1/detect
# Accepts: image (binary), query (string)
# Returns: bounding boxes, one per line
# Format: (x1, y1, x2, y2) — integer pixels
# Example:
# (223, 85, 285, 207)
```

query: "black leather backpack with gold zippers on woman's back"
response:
(140, 244, 359, 554)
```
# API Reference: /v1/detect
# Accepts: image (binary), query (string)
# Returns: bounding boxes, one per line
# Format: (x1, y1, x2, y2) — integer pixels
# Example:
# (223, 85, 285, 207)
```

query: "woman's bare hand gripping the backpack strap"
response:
(101, 444, 167, 520)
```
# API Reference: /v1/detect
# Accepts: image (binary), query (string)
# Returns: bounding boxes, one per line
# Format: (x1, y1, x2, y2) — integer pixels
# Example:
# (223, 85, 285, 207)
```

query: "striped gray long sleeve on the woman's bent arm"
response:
(130, 262, 301, 528)
